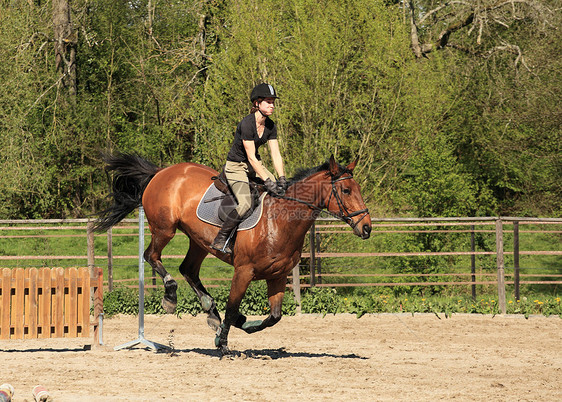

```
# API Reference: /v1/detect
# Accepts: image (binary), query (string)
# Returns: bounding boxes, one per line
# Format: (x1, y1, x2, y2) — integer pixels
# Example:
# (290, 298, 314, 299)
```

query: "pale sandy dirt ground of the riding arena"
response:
(0, 314, 562, 402)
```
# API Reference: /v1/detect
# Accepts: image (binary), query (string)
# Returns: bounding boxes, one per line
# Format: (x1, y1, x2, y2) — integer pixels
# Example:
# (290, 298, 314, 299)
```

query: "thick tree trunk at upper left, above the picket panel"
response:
(53, 0, 78, 97)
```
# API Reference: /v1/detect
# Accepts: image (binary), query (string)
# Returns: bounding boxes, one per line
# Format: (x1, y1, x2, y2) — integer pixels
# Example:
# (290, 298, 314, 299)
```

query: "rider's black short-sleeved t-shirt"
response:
(226, 113, 277, 162)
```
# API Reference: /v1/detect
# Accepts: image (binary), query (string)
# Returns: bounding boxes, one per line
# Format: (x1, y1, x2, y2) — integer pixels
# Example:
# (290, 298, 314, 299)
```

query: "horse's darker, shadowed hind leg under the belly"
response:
(180, 239, 221, 331)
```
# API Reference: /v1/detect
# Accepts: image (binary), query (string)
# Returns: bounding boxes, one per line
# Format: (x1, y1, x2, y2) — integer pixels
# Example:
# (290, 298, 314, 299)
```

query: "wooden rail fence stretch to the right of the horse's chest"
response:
(293, 217, 562, 313)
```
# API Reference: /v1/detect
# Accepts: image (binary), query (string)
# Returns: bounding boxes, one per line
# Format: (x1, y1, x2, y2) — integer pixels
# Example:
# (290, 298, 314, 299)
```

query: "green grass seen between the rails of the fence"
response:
(0, 218, 562, 295)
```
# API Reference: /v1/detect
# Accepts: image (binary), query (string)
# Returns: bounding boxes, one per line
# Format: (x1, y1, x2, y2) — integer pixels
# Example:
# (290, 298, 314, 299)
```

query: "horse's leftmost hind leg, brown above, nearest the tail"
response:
(144, 226, 178, 313)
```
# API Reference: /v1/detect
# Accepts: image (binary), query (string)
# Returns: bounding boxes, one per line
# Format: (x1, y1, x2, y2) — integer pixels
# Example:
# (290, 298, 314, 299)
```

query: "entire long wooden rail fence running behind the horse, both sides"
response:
(0, 217, 562, 314)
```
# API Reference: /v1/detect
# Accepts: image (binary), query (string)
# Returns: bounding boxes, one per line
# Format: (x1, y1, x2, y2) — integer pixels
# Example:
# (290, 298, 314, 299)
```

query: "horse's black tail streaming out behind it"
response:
(94, 154, 160, 232)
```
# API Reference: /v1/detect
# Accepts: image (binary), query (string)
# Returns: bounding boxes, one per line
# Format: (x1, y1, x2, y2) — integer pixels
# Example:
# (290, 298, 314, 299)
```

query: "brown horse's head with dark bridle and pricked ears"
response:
(323, 155, 371, 239)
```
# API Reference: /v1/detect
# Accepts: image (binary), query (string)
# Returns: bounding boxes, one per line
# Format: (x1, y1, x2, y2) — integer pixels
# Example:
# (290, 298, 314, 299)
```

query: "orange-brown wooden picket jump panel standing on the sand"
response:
(0, 268, 103, 344)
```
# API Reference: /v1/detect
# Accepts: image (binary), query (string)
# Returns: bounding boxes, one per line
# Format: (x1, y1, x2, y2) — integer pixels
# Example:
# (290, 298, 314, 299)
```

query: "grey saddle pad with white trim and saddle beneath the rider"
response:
(197, 171, 266, 230)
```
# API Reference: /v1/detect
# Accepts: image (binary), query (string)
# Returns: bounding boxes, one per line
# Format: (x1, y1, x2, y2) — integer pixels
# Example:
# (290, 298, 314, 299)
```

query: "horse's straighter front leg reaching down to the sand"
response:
(215, 267, 254, 355)
